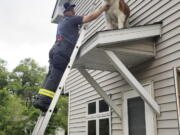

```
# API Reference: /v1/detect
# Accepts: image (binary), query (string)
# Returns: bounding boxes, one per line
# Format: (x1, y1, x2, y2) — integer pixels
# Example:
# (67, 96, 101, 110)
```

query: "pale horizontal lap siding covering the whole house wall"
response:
(66, 0, 180, 135)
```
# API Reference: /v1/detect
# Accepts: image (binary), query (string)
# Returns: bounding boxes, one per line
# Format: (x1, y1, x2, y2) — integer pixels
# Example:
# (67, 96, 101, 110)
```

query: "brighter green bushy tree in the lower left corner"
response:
(0, 89, 38, 135)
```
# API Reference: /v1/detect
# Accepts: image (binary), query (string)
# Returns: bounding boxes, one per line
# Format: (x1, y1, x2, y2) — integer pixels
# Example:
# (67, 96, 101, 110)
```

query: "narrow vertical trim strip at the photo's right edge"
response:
(174, 67, 180, 132)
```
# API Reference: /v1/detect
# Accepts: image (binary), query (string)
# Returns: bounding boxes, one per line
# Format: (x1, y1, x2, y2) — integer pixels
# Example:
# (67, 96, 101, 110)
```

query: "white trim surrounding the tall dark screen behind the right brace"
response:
(123, 84, 157, 135)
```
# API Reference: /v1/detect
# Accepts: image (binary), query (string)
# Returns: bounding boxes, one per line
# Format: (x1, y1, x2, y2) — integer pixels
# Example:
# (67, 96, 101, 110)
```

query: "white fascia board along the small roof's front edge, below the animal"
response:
(78, 24, 162, 58)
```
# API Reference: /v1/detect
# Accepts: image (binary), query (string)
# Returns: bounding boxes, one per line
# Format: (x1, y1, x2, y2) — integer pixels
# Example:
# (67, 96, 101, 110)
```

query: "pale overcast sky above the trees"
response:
(0, 0, 57, 71)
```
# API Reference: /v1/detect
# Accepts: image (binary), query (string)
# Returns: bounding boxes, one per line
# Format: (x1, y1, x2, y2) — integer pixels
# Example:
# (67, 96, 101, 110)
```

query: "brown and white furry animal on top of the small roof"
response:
(104, 0, 130, 29)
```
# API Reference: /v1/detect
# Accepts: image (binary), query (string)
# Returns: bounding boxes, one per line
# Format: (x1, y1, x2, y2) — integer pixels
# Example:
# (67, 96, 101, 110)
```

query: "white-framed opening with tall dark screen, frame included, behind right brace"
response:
(123, 83, 157, 135)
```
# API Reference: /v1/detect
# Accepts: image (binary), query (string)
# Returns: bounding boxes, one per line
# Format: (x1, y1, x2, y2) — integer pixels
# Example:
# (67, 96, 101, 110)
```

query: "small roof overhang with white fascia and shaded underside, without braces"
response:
(73, 24, 161, 71)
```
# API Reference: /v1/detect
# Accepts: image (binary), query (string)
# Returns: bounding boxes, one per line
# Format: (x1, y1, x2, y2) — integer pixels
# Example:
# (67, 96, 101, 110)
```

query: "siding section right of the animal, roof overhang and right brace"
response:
(127, 0, 180, 135)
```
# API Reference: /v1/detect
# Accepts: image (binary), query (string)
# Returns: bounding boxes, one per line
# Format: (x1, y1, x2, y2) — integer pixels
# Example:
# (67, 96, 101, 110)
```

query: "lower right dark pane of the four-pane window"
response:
(99, 119, 109, 135)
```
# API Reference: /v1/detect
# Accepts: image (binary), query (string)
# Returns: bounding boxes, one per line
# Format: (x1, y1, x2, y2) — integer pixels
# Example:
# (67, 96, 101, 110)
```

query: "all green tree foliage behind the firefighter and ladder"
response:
(0, 58, 68, 135)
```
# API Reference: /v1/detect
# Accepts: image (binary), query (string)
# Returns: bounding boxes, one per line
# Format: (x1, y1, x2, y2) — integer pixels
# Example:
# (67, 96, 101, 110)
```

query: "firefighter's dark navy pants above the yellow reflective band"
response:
(42, 40, 74, 92)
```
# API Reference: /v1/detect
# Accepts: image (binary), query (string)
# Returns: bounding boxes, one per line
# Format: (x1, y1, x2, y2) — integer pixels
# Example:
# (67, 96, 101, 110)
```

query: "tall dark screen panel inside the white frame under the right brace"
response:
(128, 97, 146, 135)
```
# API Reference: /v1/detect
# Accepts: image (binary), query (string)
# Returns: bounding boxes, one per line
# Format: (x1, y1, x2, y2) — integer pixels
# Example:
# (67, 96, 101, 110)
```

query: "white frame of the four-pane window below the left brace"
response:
(86, 98, 112, 135)
